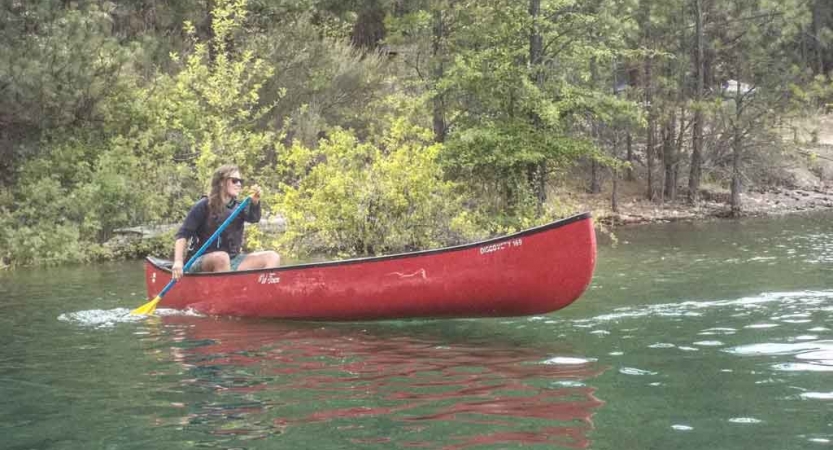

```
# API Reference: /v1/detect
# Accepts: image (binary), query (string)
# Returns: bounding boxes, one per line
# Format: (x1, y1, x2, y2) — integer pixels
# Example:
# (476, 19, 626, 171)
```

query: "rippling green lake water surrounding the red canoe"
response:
(0, 216, 833, 450)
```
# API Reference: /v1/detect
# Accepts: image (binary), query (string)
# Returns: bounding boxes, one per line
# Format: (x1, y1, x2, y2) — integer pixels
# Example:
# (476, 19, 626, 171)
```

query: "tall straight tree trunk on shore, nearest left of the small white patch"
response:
(688, 0, 706, 204)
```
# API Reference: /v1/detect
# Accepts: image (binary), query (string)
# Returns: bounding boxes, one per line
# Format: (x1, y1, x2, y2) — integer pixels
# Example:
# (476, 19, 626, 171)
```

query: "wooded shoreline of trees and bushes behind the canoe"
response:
(0, 0, 833, 267)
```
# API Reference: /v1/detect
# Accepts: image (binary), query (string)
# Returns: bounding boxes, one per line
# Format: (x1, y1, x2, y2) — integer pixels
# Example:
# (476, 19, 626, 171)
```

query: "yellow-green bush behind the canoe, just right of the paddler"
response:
(274, 119, 480, 257)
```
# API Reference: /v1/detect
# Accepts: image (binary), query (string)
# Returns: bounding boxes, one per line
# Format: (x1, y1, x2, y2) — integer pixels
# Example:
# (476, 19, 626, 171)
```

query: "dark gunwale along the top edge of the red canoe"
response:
(145, 212, 592, 277)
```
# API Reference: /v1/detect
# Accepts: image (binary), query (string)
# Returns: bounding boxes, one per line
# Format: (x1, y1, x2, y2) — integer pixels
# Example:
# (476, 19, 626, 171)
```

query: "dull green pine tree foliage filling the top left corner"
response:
(0, 1, 130, 186)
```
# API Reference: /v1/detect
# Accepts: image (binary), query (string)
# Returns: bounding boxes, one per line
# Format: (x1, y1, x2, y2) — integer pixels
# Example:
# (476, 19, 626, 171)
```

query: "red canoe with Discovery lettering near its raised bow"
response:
(145, 213, 596, 320)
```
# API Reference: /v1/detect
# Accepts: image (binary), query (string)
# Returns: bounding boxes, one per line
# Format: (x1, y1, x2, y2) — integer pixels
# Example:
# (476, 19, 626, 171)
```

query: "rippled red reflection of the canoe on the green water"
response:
(151, 316, 604, 449)
